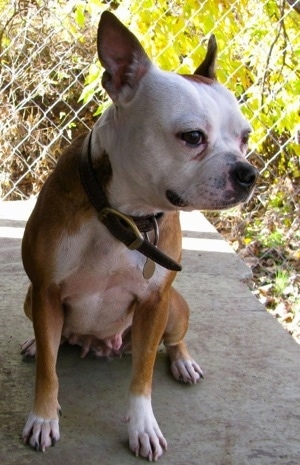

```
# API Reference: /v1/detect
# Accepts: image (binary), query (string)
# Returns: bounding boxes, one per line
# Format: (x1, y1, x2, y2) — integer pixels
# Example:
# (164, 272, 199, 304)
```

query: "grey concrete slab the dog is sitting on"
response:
(0, 202, 300, 465)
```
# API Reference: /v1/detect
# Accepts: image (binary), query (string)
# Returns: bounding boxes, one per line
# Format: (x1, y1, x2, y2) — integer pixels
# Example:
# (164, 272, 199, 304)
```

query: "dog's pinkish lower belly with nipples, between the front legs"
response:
(62, 267, 150, 355)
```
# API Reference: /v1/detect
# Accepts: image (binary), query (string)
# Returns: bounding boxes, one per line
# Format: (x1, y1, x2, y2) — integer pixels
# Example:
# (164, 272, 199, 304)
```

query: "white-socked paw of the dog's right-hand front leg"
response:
(128, 395, 167, 462)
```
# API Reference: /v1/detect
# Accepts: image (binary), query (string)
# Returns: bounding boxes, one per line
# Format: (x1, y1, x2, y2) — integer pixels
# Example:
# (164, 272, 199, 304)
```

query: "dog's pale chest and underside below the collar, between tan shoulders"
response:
(55, 217, 168, 339)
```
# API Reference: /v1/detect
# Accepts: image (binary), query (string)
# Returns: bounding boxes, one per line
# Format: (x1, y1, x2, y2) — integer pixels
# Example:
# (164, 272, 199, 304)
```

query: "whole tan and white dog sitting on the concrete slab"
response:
(22, 12, 257, 461)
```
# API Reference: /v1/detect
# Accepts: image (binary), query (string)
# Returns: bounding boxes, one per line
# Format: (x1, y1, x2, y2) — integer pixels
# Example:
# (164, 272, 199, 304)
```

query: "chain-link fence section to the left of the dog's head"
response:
(0, 1, 99, 199)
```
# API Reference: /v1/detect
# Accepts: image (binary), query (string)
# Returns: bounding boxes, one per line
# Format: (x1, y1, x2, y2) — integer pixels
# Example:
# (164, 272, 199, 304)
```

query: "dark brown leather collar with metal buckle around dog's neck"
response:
(79, 131, 182, 271)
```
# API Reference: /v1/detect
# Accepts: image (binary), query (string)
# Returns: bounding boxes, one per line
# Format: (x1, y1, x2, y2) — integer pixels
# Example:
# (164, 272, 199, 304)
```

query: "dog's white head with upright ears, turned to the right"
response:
(95, 12, 257, 214)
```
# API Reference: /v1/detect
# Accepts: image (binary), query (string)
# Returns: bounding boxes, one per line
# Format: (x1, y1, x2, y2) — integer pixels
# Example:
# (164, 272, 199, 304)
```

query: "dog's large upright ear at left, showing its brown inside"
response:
(97, 11, 151, 101)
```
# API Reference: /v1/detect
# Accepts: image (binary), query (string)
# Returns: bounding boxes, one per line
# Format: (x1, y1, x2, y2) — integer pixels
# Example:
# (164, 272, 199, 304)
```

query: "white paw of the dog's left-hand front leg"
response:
(22, 412, 59, 452)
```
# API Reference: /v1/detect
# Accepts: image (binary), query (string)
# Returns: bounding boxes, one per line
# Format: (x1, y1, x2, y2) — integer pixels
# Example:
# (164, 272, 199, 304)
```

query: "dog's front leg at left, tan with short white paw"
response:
(22, 286, 63, 452)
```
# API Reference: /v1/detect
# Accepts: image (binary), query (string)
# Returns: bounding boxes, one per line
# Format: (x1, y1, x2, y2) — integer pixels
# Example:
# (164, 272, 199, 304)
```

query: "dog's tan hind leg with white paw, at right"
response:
(163, 287, 203, 384)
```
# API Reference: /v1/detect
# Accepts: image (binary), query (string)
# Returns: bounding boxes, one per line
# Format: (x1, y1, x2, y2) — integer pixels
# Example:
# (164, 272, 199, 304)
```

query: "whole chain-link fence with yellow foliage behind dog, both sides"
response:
(0, 0, 300, 334)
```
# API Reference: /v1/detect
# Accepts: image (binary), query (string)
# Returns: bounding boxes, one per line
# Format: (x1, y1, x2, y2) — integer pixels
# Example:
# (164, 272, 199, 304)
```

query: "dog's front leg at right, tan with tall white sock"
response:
(128, 292, 169, 461)
